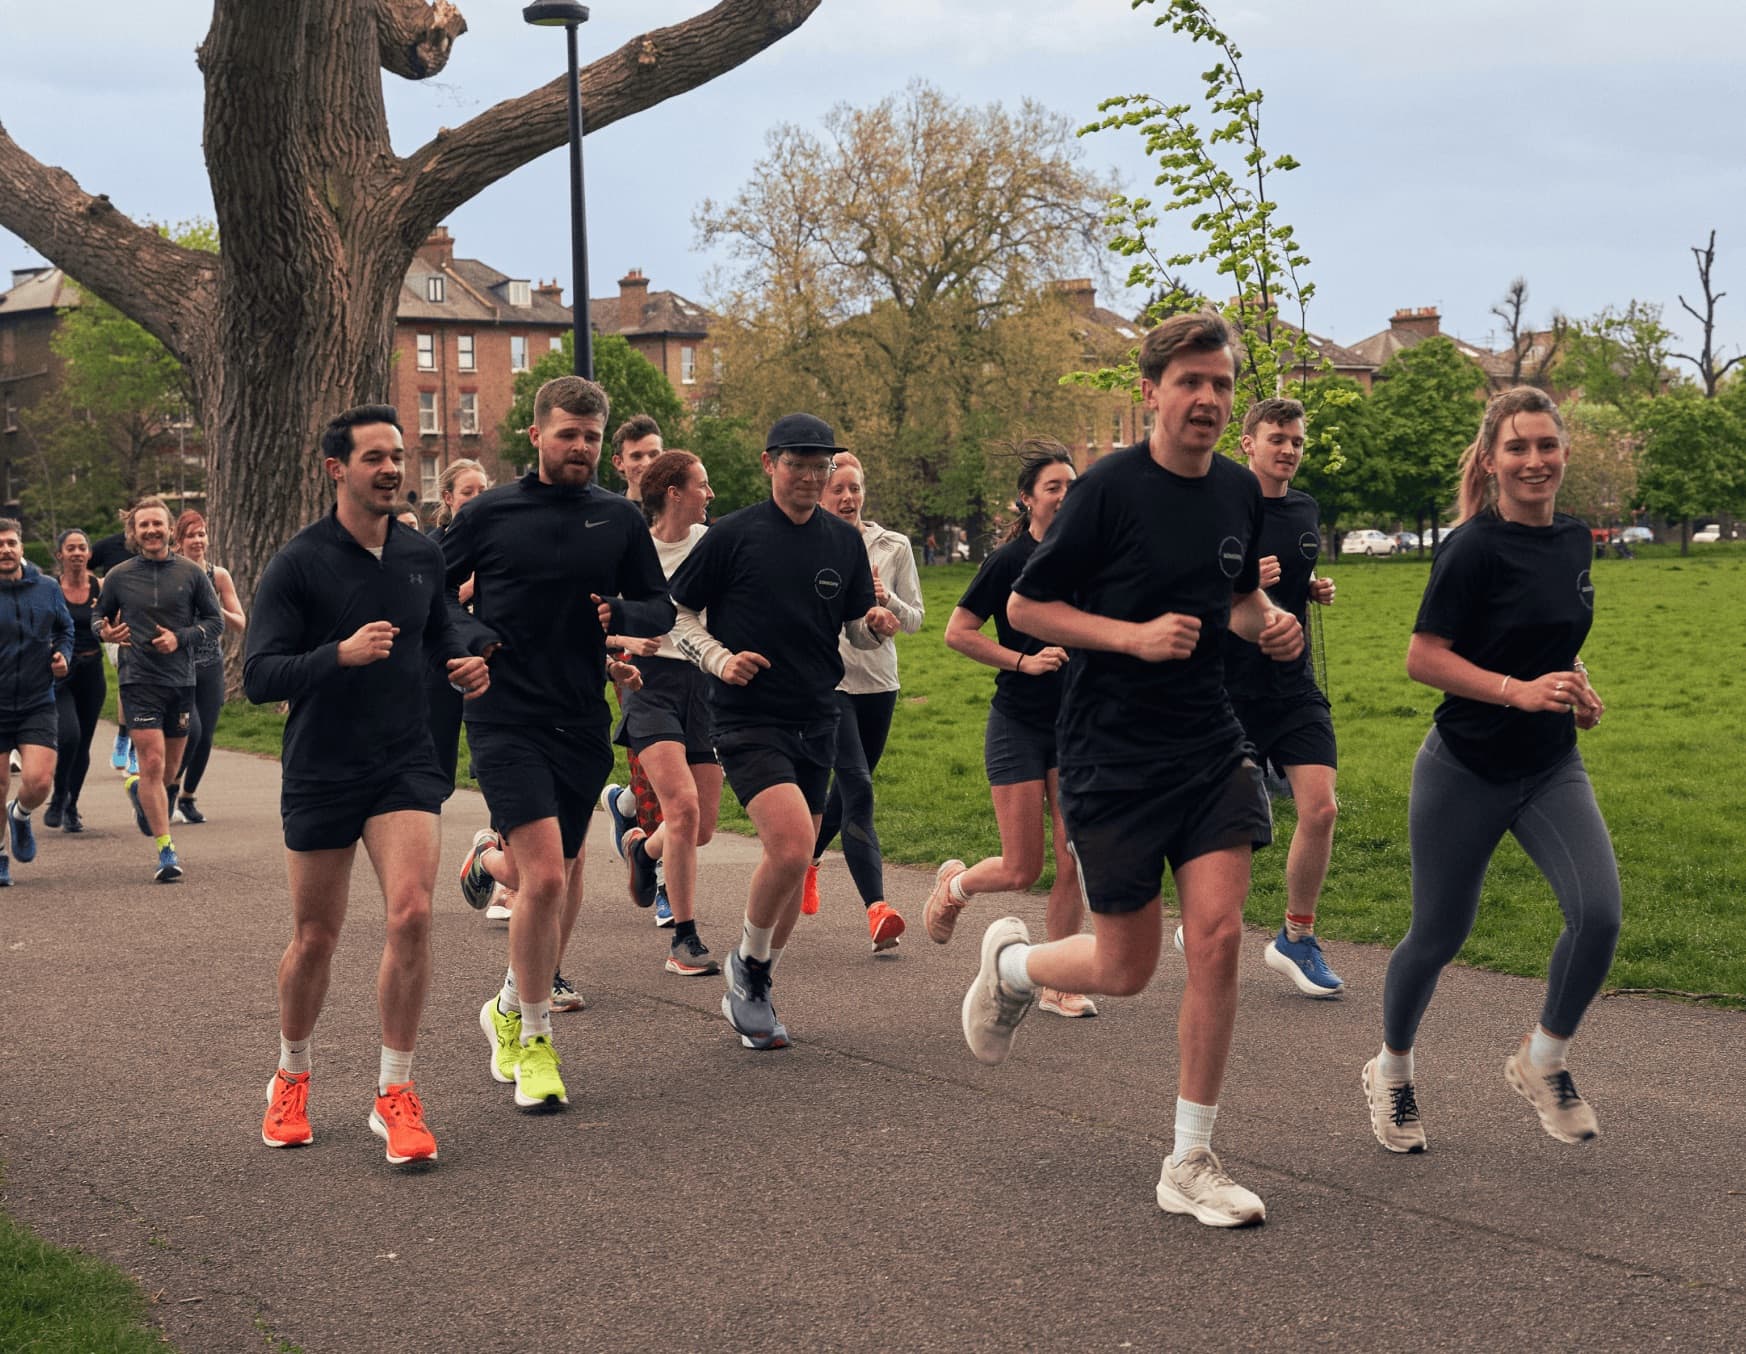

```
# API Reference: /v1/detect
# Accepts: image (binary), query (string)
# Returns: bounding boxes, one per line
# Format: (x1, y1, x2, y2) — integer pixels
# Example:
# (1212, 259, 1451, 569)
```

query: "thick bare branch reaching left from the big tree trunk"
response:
(0, 126, 218, 360)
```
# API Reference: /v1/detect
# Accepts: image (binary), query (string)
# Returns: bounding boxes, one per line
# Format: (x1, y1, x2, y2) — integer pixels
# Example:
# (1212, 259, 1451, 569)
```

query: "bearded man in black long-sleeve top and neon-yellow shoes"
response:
(442, 376, 674, 1109)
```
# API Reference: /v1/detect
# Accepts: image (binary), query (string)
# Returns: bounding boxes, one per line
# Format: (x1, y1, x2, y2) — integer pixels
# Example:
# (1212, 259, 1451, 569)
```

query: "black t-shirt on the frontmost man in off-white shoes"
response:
(1013, 442, 1261, 790)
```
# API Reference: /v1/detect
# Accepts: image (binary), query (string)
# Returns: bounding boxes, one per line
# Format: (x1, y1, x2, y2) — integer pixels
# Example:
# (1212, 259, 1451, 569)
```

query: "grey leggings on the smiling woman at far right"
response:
(1383, 729, 1620, 1052)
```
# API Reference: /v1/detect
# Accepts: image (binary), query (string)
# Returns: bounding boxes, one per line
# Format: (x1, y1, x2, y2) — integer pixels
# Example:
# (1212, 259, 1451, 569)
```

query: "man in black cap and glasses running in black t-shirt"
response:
(669, 414, 897, 1048)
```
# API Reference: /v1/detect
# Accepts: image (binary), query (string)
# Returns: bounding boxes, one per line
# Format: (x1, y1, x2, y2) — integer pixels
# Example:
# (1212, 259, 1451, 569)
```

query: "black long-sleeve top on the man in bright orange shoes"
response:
(243, 512, 466, 784)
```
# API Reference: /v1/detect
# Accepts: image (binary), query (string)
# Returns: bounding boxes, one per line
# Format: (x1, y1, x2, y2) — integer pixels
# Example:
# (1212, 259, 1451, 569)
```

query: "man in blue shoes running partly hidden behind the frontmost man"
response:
(1224, 398, 1346, 998)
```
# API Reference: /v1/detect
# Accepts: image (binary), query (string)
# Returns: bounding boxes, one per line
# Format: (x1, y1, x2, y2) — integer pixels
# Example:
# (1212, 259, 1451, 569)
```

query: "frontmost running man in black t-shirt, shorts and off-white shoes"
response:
(962, 314, 1303, 1226)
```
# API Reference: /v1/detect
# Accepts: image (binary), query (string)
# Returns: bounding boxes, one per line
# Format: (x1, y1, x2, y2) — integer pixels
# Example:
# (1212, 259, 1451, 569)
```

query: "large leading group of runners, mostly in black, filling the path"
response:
(221, 314, 1619, 1226)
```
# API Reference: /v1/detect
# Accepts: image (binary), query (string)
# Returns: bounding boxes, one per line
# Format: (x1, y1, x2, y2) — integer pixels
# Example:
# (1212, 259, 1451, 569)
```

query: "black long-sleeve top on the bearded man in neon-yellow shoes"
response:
(442, 473, 674, 729)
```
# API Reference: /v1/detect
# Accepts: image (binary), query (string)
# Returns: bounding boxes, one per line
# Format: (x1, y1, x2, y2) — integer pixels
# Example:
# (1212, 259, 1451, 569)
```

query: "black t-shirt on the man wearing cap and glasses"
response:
(669, 500, 873, 730)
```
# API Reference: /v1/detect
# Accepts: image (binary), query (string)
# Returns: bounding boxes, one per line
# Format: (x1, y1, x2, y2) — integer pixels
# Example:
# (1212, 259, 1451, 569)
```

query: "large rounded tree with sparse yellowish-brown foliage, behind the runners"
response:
(695, 82, 1105, 529)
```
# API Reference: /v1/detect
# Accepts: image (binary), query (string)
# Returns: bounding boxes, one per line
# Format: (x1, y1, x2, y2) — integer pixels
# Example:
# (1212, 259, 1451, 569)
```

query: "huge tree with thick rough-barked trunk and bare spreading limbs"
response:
(0, 0, 821, 603)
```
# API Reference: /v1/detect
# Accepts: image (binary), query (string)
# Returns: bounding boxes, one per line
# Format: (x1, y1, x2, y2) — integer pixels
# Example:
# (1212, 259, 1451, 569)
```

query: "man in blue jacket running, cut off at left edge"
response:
(0, 517, 73, 888)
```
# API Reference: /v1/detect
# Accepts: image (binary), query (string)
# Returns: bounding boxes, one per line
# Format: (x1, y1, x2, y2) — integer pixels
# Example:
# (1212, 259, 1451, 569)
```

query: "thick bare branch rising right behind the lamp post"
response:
(400, 0, 822, 239)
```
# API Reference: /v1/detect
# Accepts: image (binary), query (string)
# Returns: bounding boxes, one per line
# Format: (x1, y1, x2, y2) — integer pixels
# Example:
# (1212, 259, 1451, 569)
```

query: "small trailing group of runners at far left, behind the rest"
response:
(0, 496, 246, 886)
